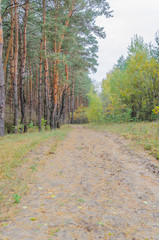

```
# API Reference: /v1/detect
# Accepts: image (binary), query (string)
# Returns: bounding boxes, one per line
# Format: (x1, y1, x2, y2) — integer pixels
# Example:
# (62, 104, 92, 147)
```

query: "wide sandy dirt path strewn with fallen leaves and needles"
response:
(0, 126, 159, 240)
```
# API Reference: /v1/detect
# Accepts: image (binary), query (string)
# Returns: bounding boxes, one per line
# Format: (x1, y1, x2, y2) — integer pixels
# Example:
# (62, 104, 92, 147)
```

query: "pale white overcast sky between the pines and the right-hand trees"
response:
(91, 0, 159, 82)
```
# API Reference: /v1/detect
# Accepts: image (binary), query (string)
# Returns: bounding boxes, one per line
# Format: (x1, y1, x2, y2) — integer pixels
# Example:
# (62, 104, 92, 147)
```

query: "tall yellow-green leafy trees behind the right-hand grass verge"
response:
(102, 36, 159, 122)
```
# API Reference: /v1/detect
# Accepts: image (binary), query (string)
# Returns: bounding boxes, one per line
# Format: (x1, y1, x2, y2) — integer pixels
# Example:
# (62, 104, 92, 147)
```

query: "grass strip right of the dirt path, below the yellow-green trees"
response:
(90, 121, 159, 159)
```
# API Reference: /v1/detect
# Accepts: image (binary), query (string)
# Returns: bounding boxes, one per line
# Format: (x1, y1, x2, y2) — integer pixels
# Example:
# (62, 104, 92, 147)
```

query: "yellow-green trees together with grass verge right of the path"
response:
(85, 32, 159, 159)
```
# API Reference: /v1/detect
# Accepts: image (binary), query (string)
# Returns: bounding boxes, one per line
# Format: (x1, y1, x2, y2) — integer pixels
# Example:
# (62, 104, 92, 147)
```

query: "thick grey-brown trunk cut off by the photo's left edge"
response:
(0, 0, 5, 136)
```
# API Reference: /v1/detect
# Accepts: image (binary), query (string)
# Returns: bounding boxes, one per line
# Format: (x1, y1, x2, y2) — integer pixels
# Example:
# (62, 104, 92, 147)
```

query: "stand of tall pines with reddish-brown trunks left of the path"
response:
(0, 0, 111, 135)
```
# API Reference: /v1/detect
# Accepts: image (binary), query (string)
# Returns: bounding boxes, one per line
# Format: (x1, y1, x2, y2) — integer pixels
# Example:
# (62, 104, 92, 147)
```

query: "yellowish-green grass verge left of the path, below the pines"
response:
(0, 126, 70, 218)
